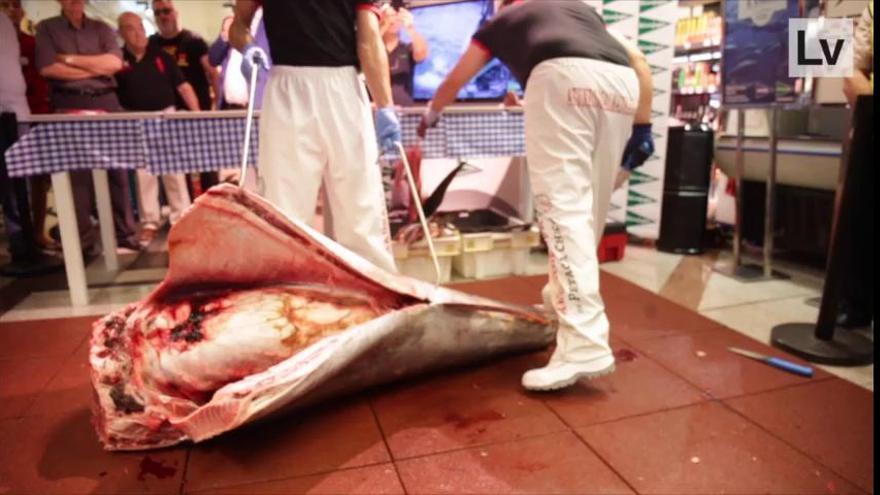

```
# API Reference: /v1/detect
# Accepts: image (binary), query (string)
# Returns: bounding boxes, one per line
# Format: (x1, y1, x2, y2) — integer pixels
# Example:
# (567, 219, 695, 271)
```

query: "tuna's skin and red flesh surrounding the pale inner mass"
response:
(89, 184, 555, 450)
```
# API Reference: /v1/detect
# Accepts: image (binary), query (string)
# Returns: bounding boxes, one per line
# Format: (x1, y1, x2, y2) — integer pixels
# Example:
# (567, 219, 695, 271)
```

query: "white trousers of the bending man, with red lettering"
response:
(525, 58, 639, 362)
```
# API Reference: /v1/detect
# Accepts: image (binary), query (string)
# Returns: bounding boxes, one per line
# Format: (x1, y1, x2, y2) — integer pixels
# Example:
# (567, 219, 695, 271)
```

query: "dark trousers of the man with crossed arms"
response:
(52, 93, 137, 251)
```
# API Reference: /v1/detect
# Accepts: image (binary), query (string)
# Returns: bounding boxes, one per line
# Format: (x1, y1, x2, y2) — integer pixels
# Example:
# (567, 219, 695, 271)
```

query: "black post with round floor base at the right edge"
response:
(770, 97, 874, 366)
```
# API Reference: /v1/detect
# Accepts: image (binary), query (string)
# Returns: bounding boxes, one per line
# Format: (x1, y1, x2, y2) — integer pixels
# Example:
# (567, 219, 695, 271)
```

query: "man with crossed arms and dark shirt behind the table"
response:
(36, 0, 139, 252)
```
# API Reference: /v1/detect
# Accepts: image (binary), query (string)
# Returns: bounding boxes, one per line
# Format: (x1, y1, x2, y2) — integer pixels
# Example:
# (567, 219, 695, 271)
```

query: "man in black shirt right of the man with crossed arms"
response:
(116, 12, 199, 246)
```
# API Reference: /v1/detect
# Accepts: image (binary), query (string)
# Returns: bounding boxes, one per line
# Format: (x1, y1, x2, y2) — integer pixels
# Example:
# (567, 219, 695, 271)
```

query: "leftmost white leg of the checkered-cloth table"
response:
(52, 172, 89, 306)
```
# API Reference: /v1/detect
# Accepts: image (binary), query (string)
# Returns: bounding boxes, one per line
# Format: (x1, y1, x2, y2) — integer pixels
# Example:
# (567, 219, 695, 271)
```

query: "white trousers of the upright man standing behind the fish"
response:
(258, 65, 396, 272)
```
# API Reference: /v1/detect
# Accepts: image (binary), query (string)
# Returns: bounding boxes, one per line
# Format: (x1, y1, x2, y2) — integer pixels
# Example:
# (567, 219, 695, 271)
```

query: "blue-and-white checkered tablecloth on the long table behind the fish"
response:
(6, 112, 525, 177)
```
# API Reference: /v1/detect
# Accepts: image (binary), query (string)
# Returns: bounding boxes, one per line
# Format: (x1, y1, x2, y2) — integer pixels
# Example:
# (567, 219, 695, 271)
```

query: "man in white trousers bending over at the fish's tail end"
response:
(419, 0, 653, 390)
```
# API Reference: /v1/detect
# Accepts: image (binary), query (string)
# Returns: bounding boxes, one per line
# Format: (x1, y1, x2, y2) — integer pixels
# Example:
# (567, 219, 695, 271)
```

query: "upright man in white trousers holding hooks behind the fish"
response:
(230, 0, 400, 271)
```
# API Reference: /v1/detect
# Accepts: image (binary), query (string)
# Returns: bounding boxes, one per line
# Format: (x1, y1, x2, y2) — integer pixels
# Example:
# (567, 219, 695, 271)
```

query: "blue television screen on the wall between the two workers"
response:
(401, 0, 522, 101)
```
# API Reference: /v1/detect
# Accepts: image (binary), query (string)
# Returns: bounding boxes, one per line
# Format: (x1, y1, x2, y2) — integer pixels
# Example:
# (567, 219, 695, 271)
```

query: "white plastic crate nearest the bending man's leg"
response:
(452, 227, 541, 279)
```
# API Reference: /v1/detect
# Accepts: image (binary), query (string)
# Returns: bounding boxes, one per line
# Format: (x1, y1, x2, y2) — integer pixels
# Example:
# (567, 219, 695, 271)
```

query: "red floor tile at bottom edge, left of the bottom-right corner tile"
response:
(578, 403, 860, 495)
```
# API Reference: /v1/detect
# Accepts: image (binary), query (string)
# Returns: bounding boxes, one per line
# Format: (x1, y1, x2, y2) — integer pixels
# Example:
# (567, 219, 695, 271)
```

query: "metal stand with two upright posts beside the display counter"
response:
(714, 106, 790, 282)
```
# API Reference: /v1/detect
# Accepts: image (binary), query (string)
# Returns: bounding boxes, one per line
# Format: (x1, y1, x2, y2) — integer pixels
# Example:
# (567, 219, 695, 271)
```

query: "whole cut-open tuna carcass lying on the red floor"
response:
(89, 185, 553, 450)
